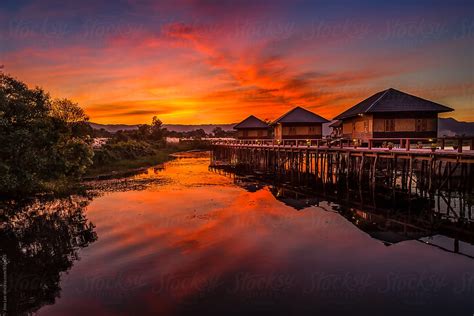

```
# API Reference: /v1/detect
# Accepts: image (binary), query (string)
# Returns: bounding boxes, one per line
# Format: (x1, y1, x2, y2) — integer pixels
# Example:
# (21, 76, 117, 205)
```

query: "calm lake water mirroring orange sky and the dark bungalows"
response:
(2, 152, 474, 316)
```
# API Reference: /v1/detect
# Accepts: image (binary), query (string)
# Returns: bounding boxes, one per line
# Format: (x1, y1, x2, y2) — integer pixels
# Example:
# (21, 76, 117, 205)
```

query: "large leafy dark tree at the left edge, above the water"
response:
(0, 73, 94, 196)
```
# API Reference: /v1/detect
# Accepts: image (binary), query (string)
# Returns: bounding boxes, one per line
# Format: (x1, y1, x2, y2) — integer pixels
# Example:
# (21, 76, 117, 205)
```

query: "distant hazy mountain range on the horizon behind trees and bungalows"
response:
(89, 117, 474, 136)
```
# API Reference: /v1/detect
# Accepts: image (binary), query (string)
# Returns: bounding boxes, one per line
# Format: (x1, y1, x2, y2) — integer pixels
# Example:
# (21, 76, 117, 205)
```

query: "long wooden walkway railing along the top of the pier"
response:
(212, 137, 474, 153)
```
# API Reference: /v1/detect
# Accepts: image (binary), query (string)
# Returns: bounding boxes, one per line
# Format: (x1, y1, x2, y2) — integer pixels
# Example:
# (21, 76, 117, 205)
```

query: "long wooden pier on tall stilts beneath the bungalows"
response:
(211, 139, 474, 193)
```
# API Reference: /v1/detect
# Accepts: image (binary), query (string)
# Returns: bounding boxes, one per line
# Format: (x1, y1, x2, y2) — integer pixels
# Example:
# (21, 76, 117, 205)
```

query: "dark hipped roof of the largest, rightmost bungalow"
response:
(334, 88, 453, 120)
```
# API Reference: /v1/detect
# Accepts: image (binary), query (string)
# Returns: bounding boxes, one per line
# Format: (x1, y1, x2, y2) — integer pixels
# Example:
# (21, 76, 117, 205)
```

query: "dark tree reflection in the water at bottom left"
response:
(0, 197, 97, 315)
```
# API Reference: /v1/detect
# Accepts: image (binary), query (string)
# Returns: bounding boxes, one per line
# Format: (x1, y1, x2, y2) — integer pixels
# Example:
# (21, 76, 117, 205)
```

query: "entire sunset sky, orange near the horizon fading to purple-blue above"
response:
(0, 0, 474, 124)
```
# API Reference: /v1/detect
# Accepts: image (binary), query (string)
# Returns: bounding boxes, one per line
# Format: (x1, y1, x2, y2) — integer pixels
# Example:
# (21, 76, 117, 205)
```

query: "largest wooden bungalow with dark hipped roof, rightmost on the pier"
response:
(334, 88, 453, 142)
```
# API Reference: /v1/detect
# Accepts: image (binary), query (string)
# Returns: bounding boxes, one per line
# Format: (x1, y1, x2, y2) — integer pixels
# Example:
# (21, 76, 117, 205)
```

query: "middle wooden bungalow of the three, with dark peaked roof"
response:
(272, 106, 329, 140)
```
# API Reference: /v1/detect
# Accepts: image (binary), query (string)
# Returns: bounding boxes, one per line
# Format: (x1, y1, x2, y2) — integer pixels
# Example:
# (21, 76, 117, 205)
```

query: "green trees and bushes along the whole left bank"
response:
(0, 72, 217, 199)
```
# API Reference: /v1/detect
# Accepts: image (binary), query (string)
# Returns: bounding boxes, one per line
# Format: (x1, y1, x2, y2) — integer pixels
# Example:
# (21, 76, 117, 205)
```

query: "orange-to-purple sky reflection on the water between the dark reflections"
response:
(35, 158, 472, 315)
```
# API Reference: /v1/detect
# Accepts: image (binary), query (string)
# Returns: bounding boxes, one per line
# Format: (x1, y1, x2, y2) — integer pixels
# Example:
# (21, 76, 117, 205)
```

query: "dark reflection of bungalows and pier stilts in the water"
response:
(211, 167, 474, 259)
